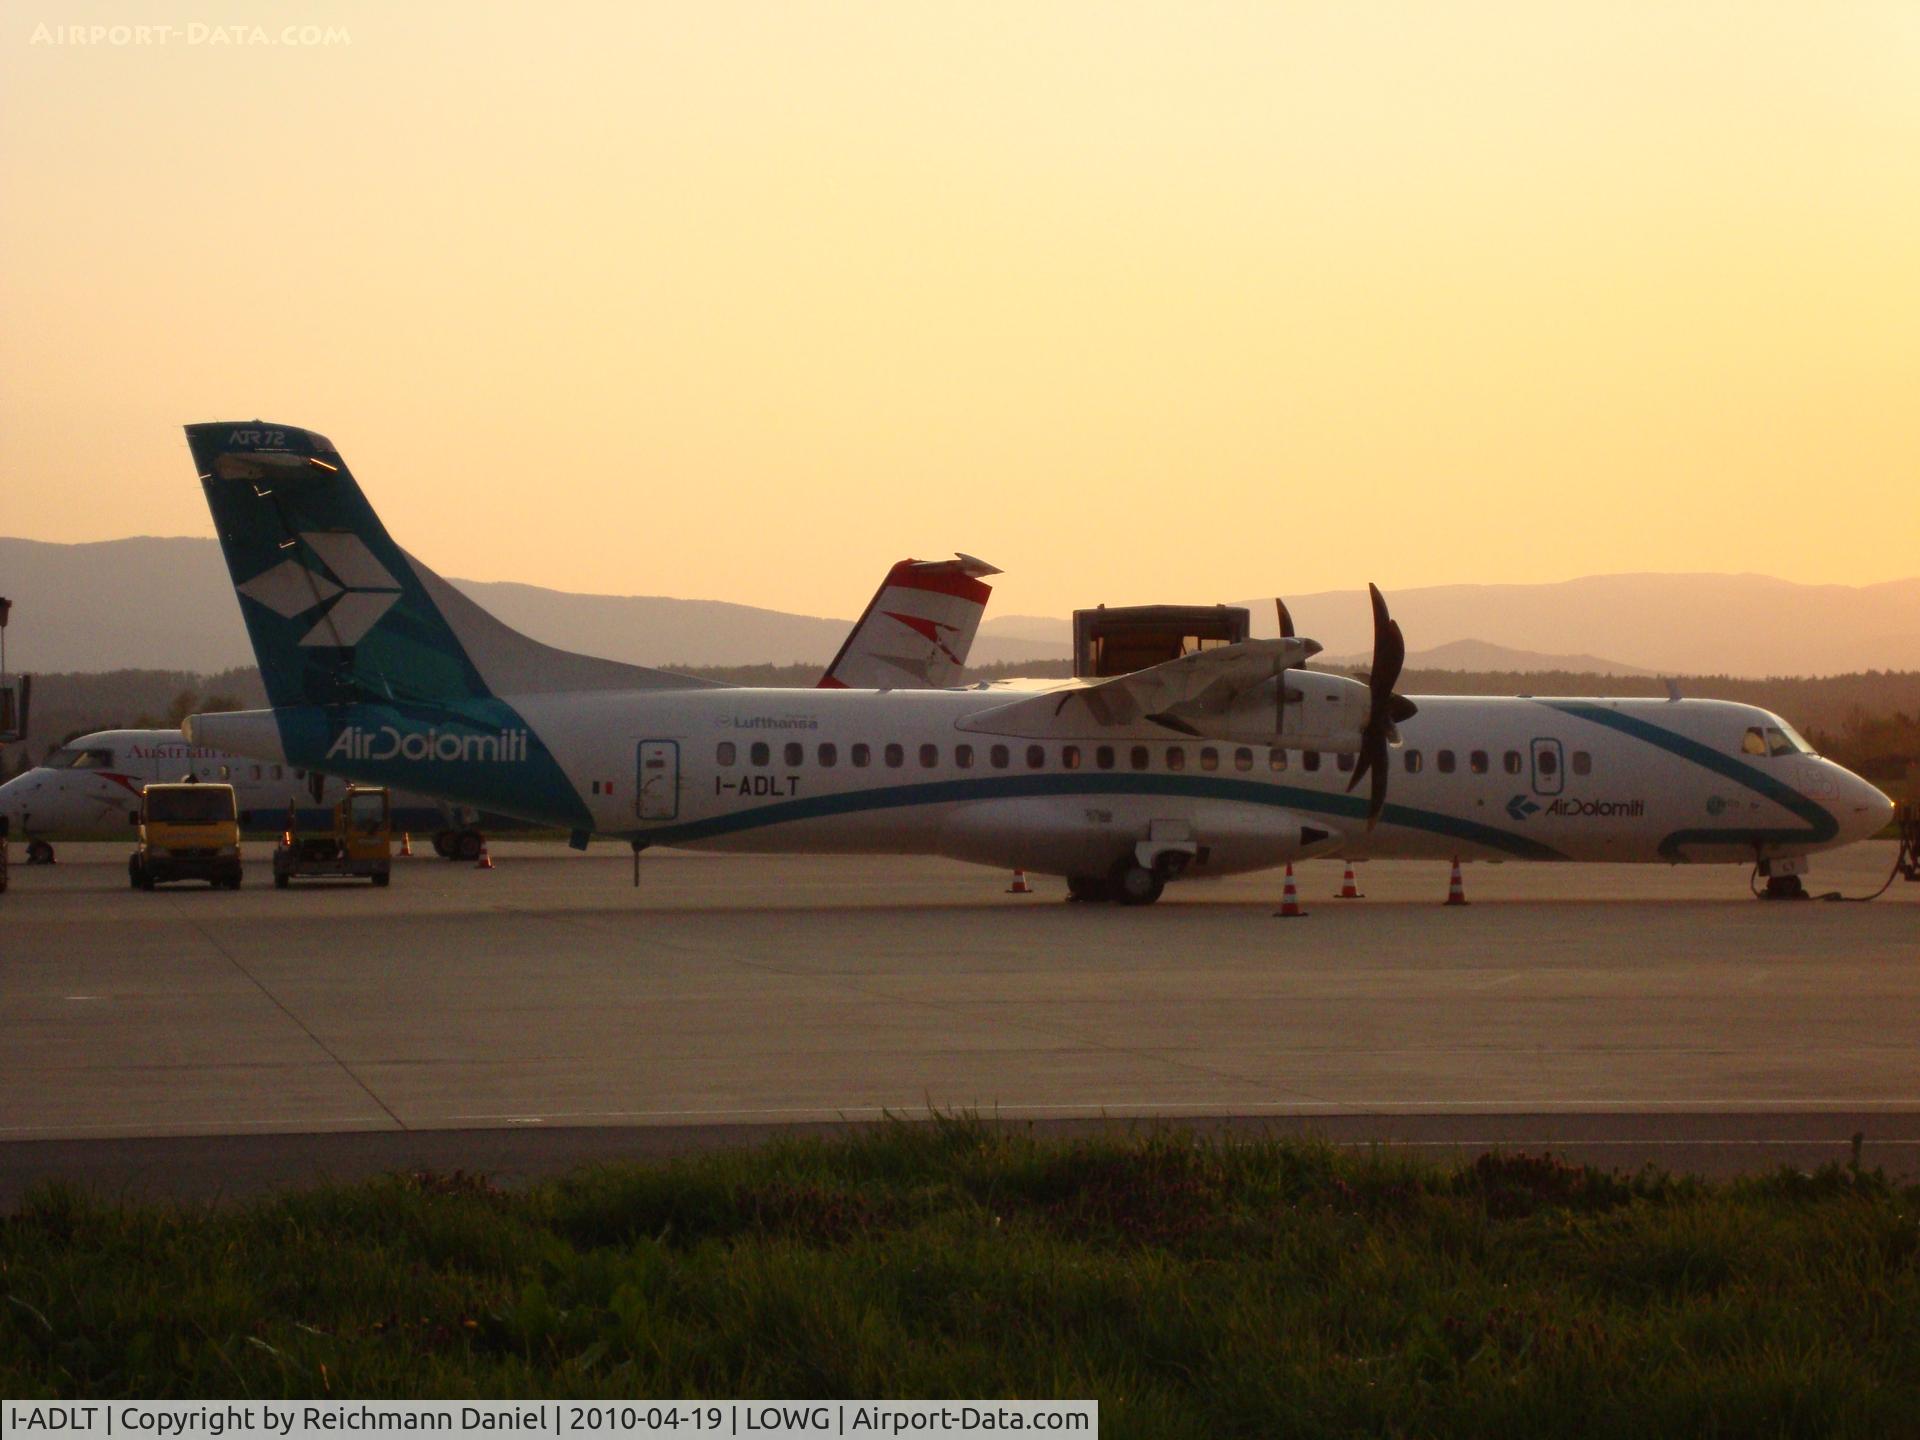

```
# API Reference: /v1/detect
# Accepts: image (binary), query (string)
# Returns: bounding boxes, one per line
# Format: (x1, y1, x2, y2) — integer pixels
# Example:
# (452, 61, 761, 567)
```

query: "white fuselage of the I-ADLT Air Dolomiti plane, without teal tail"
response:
(194, 687, 1891, 876)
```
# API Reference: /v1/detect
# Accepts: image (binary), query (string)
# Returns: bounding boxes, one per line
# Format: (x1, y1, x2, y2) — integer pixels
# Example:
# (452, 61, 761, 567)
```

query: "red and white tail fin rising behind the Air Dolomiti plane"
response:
(820, 555, 1000, 689)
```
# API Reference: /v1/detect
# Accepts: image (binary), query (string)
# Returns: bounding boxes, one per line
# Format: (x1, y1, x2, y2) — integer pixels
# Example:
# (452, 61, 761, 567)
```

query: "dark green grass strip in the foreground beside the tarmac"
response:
(0, 1117, 1920, 1436)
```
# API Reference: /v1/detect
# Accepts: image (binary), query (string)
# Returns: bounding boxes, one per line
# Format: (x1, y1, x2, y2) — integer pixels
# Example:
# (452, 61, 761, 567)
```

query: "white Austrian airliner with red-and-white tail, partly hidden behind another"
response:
(0, 555, 1000, 864)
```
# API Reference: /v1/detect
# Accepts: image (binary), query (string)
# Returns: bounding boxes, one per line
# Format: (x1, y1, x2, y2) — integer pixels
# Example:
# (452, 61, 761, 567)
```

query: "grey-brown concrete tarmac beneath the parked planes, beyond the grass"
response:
(0, 843, 1920, 1200)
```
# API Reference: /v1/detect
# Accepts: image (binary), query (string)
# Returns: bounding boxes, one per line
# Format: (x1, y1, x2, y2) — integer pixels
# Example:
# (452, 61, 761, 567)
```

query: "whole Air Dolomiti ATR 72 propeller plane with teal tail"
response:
(186, 420, 1893, 904)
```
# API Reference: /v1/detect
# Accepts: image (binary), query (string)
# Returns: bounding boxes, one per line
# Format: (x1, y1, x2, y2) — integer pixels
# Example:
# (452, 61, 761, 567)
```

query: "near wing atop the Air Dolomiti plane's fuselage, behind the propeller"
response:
(960, 637, 1319, 737)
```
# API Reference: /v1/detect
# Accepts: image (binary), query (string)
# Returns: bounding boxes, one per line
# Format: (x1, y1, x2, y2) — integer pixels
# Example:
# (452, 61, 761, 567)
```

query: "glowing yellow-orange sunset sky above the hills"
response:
(0, 0, 1920, 614)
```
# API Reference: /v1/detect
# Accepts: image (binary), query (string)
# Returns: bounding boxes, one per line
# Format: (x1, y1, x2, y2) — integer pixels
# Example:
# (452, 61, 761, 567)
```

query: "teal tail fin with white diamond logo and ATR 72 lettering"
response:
(186, 420, 708, 707)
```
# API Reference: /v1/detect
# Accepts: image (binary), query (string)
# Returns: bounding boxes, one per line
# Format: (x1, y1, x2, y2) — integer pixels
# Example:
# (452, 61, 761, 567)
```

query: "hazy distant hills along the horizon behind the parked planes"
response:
(0, 538, 1920, 676)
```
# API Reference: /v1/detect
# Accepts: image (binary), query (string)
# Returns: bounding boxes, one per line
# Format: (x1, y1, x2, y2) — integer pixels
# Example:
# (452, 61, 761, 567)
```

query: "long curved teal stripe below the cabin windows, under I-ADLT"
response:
(630, 772, 1567, 860)
